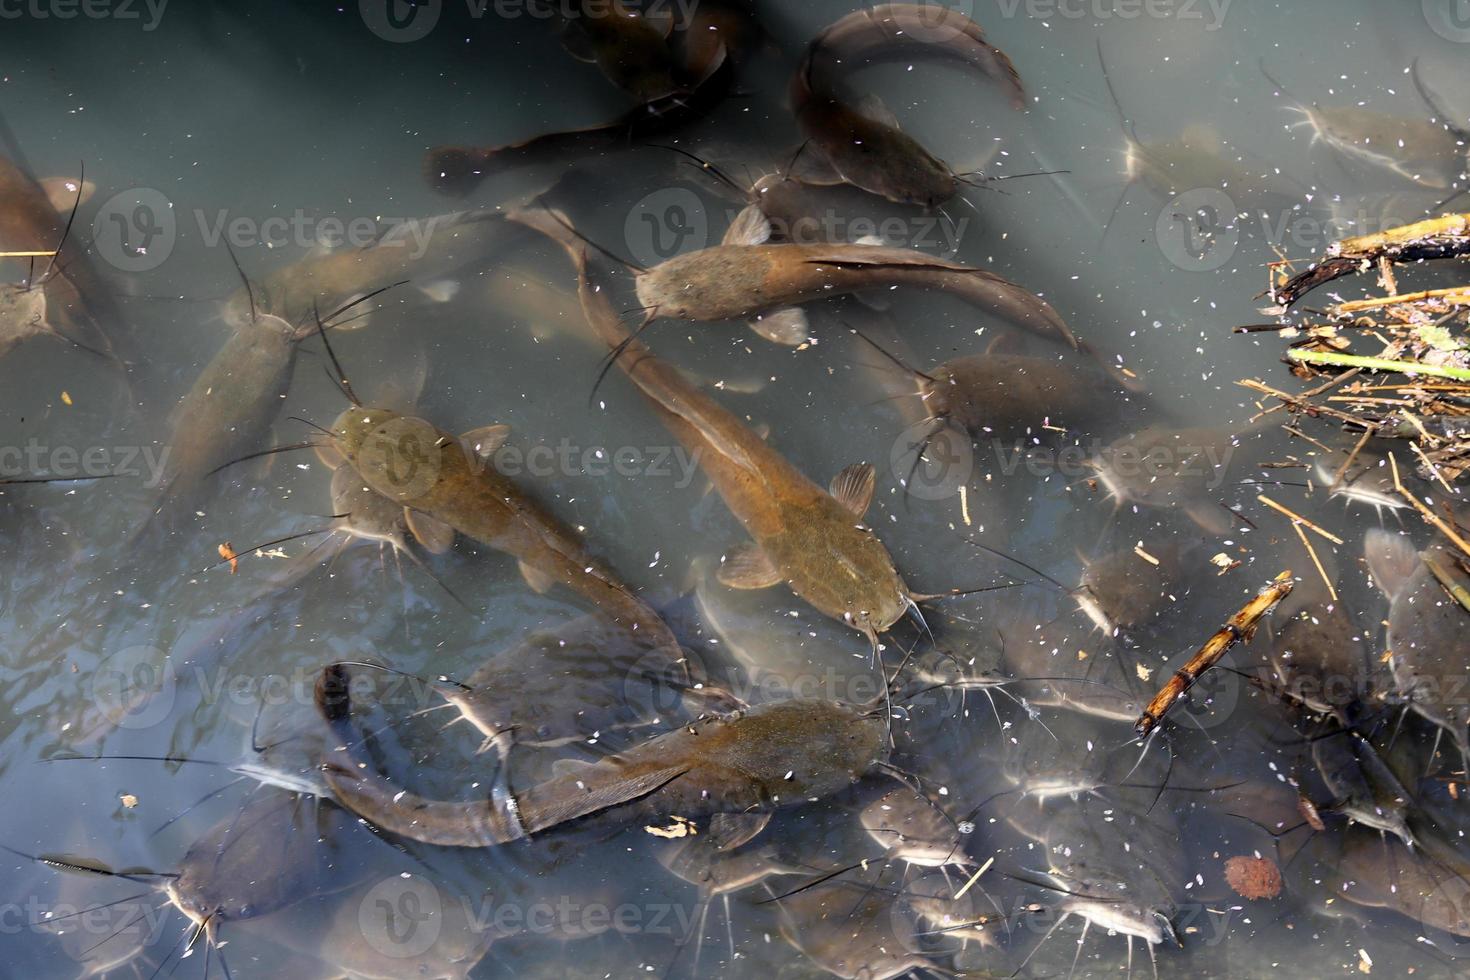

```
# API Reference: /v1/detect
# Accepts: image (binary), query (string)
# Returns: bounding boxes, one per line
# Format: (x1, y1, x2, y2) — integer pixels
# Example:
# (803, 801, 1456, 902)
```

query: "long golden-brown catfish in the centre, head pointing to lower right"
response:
(581, 243, 922, 649)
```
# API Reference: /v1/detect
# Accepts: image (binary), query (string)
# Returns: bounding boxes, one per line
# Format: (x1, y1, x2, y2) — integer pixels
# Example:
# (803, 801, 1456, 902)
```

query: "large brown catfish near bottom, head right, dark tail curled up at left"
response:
(316, 664, 888, 848)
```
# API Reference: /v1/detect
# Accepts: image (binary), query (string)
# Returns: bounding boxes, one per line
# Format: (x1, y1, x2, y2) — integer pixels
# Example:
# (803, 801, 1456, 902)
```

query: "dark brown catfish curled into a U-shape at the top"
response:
(791, 4, 1025, 210)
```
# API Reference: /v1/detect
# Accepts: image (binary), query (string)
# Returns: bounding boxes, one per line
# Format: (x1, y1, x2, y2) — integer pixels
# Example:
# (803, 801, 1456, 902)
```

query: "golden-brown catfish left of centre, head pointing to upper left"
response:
(331, 407, 678, 651)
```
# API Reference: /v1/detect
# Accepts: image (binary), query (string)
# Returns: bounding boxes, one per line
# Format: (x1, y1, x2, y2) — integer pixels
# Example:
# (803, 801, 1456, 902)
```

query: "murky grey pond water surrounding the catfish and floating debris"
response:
(0, 0, 1470, 977)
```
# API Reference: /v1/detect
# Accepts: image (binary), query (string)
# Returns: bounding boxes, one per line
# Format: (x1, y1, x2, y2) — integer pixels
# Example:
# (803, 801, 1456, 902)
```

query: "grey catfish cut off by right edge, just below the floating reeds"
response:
(1363, 527, 1470, 765)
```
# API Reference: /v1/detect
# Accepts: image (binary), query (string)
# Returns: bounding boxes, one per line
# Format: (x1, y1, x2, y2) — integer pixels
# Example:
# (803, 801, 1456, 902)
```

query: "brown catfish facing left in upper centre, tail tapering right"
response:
(637, 209, 1089, 357)
